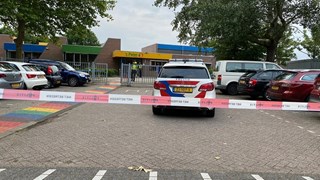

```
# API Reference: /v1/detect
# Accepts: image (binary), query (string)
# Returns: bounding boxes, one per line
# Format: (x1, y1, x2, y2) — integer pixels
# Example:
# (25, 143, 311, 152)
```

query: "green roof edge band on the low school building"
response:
(62, 44, 102, 54)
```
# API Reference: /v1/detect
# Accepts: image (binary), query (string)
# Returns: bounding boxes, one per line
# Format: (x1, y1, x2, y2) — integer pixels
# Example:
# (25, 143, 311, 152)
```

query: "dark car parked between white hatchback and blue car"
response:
(35, 64, 62, 88)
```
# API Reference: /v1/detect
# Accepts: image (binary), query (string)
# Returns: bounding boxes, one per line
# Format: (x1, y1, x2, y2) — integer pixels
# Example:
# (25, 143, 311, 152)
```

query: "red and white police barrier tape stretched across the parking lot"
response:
(0, 89, 320, 111)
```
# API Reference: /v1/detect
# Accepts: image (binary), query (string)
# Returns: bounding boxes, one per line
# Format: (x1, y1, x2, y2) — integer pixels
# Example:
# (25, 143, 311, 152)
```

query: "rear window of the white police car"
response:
(159, 66, 210, 79)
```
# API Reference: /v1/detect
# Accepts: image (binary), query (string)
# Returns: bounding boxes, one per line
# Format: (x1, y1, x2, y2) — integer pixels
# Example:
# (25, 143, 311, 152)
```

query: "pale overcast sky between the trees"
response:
(92, 0, 308, 59)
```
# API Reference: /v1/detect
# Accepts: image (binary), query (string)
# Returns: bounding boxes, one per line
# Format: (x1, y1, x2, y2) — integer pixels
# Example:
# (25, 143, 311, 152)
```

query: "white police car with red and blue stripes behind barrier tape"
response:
(152, 60, 216, 117)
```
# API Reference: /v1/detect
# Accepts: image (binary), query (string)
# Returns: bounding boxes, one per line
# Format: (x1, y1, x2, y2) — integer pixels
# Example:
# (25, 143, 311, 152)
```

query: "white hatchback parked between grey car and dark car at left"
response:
(7, 61, 48, 90)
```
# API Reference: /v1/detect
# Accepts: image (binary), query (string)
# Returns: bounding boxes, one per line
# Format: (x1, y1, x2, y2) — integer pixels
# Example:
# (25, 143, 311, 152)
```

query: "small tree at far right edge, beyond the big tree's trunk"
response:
(298, 27, 320, 59)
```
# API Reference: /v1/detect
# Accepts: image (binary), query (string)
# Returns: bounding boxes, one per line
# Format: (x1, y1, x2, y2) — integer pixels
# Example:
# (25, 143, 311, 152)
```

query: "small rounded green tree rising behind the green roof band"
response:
(66, 28, 100, 46)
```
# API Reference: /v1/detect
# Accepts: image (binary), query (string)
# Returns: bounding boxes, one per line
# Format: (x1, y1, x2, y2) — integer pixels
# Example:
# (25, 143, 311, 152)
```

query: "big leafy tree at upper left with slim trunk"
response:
(0, 0, 116, 58)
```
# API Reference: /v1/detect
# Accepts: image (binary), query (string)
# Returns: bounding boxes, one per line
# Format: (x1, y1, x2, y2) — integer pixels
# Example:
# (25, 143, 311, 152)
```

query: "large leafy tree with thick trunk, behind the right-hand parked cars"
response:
(155, 0, 320, 62)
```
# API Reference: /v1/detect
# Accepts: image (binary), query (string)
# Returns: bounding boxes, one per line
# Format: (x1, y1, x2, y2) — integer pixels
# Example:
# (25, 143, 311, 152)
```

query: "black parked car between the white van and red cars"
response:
(238, 69, 285, 99)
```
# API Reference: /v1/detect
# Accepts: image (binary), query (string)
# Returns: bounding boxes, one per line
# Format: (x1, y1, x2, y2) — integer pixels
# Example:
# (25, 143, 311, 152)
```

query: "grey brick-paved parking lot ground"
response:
(0, 82, 320, 179)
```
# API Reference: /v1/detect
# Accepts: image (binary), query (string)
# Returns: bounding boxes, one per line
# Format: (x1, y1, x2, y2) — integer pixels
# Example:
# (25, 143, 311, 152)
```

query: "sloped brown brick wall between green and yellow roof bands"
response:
(94, 38, 121, 69)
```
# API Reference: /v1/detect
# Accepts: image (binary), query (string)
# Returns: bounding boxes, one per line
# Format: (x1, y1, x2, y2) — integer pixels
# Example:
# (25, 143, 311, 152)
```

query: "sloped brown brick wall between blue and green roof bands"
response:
(40, 37, 68, 61)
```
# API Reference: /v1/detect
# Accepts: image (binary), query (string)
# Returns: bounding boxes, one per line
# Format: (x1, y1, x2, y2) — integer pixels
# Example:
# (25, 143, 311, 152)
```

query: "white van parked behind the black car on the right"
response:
(213, 60, 282, 95)
